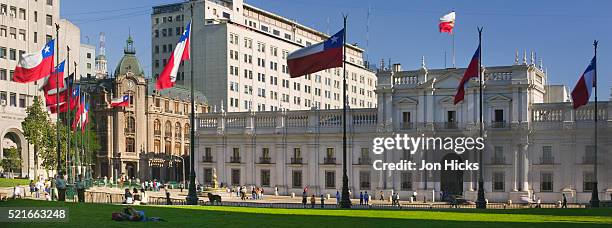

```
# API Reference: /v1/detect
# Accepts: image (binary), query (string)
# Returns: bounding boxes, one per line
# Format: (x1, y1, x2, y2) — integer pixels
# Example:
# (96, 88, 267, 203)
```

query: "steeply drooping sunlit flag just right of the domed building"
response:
(155, 21, 191, 90)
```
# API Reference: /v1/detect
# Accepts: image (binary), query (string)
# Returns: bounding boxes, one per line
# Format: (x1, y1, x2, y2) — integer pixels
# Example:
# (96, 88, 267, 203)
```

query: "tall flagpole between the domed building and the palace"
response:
(186, 2, 198, 205)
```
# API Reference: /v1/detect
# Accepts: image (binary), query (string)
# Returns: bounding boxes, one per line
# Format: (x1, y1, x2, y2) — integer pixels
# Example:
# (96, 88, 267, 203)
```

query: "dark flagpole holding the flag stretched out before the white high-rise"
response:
(340, 15, 351, 208)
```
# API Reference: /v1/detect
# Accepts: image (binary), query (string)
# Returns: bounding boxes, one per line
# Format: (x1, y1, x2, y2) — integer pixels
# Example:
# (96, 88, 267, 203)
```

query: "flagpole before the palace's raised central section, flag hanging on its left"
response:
(476, 27, 487, 209)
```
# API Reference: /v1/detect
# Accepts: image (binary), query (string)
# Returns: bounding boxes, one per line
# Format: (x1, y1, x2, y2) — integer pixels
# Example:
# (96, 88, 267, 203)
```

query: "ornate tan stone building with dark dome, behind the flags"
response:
(81, 36, 208, 182)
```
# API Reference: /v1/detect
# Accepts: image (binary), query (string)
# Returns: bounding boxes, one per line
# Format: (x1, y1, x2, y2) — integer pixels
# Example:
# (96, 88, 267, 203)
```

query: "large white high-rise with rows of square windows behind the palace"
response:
(151, 0, 376, 112)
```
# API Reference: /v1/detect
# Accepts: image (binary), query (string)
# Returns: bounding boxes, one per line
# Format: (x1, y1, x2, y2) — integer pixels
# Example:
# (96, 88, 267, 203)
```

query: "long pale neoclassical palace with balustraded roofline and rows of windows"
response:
(196, 60, 612, 203)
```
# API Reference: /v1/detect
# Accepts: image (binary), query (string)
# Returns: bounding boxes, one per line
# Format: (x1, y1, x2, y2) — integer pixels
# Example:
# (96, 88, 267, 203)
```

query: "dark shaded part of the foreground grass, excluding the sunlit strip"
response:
(0, 200, 610, 228)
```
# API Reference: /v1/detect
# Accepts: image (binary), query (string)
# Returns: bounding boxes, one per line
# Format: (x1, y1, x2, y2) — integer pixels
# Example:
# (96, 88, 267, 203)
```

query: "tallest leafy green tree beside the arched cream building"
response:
(21, 96, 54, 176)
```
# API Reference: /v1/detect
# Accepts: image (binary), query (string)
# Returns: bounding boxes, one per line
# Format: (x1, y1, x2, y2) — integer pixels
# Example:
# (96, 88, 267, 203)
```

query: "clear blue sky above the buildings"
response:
(61, 0, 612, 100)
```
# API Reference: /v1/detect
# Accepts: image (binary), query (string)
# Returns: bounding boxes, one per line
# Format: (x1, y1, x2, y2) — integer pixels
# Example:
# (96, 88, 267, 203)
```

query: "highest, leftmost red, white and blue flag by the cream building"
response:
(13, 40, 55, 83)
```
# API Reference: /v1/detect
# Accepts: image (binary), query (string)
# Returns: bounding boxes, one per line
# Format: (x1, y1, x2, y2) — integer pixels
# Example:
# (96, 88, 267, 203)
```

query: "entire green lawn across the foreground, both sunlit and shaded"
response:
(0, 200, 612, 228)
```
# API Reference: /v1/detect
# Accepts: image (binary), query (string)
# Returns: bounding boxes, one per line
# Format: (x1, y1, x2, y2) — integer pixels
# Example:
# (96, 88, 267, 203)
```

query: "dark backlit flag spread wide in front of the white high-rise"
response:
(287, 29, 344, 78)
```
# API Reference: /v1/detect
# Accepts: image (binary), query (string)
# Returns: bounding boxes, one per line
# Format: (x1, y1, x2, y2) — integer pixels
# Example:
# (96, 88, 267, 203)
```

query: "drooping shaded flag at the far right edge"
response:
(572, 57, 597, 109)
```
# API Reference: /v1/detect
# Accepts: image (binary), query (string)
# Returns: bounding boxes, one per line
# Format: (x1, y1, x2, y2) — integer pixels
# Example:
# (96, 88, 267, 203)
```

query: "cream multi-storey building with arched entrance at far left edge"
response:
(0, 0, 81, 176)
